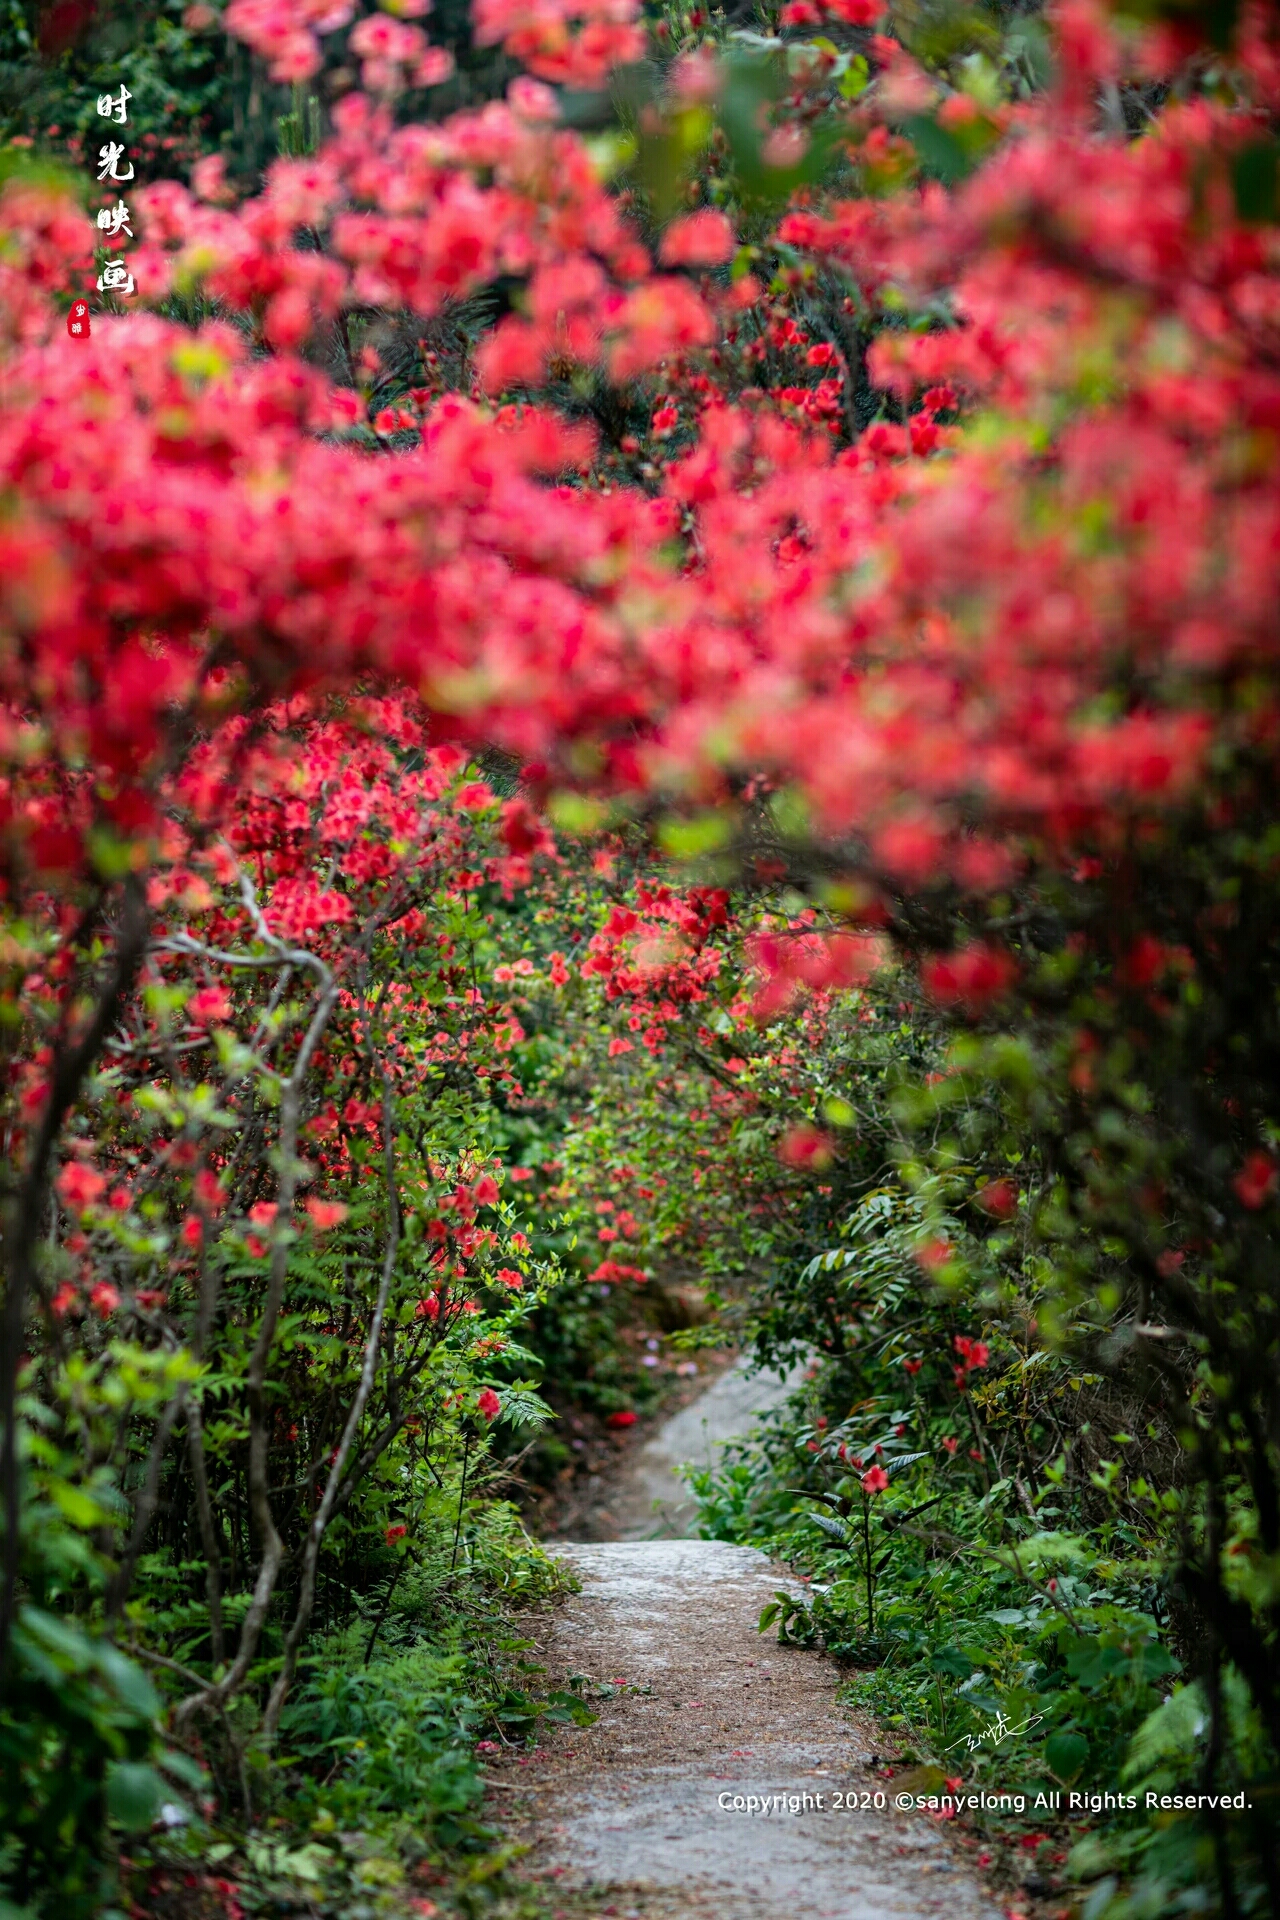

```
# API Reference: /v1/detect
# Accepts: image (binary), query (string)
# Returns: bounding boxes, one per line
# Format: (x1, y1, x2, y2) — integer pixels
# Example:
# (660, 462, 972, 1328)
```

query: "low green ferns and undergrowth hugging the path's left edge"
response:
(110, 1501, 575, 1920)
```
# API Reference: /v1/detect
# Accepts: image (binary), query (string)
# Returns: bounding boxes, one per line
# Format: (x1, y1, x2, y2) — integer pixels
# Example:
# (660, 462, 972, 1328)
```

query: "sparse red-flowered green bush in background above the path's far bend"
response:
(553, 879, 898, 1283)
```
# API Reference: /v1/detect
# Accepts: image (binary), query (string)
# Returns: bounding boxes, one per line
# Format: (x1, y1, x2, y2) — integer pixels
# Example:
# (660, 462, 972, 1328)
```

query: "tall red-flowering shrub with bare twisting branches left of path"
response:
(6, 699, 571, 1910)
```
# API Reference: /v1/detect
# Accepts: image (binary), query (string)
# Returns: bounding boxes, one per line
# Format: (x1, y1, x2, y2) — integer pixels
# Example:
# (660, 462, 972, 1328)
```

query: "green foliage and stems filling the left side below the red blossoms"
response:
(0, 735, 617, 1920)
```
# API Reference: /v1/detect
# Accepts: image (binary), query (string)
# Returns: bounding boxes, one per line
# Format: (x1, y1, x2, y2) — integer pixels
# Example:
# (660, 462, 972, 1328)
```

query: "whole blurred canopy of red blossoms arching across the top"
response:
(0, 6, 1280, 933)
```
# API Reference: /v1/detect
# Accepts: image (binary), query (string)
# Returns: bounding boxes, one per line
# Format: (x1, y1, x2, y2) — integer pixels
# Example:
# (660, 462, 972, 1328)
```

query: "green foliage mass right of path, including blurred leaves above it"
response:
(633, 936, 1276, 1920)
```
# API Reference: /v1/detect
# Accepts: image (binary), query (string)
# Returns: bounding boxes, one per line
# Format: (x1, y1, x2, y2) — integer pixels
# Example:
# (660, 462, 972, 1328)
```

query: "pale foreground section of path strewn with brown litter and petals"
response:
(489, 1377, 998, 1920)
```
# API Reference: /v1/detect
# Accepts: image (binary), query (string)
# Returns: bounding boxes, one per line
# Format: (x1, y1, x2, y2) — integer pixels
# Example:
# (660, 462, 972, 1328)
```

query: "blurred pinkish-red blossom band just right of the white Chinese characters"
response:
(121, 90, 733, 374)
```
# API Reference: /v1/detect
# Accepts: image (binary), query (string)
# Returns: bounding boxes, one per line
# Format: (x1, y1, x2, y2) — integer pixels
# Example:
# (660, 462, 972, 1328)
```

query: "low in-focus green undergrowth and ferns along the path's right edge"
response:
(689, 1144, 1276, 1920)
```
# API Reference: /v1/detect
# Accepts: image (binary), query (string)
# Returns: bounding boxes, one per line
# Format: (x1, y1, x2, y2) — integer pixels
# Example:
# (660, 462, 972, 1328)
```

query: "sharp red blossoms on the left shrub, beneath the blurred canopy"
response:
(42, 697, 555, 1332)
